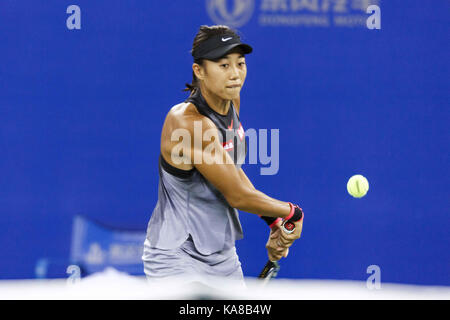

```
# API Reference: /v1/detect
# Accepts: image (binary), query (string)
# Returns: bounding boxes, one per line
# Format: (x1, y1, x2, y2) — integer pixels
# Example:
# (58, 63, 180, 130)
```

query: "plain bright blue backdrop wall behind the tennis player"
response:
(0, 0, 450, 285)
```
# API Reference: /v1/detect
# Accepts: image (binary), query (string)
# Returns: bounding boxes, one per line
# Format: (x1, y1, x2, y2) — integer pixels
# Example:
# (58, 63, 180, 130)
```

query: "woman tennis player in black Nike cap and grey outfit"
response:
(142, 26, 303, 283)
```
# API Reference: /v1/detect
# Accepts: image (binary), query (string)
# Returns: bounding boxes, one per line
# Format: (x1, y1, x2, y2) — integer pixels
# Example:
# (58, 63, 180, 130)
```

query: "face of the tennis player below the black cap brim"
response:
(198, 53, 247, 100)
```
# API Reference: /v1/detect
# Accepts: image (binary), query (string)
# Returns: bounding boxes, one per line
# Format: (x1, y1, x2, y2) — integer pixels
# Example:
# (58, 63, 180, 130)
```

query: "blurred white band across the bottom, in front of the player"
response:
(0, 269, 450, 300)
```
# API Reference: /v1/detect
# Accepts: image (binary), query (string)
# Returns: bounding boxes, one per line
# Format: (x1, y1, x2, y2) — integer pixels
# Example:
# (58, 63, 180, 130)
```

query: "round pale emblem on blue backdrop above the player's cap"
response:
(206, 0, 255, 28)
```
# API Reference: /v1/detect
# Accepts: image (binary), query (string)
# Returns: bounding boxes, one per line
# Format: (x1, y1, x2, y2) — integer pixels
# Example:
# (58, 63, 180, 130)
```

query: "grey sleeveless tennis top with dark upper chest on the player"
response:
(147, 90, 247, 255)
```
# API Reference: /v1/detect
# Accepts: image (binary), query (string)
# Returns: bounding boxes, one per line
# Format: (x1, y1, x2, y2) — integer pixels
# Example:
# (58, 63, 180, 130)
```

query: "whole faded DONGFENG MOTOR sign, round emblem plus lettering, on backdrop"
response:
(206, 0, 381, 29)
